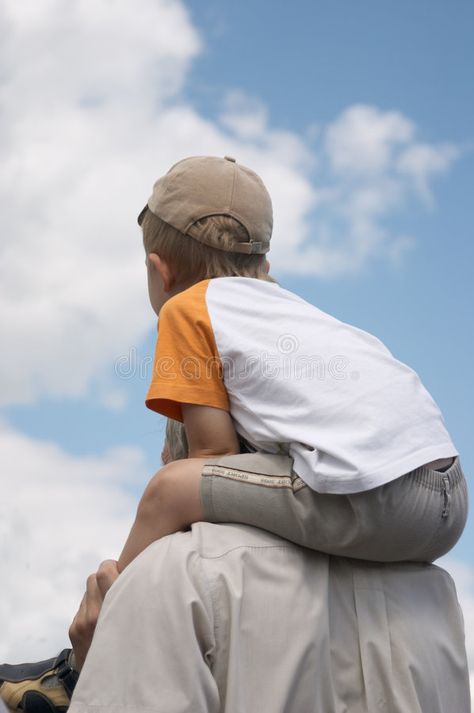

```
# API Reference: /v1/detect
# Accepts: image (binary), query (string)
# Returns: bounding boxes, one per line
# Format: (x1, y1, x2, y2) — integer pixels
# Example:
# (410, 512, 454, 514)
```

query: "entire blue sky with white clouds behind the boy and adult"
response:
(0, 0, 474, 696)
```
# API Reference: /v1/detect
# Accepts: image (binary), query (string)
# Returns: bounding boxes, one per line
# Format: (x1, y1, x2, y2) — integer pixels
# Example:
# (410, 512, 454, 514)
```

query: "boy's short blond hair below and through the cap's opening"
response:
(141, 210, 278, 288)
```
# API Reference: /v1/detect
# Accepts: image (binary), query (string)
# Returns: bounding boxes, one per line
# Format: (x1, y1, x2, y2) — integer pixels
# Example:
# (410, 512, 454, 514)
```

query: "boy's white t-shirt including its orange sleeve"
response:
(146, 277, 458, 493)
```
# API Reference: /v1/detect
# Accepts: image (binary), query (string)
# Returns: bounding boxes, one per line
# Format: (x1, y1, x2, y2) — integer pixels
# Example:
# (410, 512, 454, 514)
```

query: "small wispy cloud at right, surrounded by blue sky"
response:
(285, 105, 461, 278)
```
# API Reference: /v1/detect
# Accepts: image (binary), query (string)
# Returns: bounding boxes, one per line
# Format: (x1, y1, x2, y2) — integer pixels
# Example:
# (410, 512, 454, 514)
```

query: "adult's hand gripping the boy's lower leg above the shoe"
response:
(69, 560, 119, 671)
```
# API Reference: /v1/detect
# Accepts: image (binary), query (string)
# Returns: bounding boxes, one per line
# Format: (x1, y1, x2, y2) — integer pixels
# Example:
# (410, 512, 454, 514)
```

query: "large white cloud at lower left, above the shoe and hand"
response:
(0, 425, 149, 662)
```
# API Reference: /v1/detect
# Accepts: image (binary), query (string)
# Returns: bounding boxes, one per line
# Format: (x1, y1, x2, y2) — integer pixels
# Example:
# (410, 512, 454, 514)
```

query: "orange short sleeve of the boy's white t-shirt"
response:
(145, 280, 230, 422)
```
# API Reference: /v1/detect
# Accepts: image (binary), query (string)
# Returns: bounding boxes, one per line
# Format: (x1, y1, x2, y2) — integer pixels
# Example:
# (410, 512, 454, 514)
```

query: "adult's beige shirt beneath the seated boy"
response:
(69, 523, 470, 713)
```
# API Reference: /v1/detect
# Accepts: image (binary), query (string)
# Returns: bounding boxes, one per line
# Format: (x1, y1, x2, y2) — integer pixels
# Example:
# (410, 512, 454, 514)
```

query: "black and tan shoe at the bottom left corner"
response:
(0, 649, 79, 713)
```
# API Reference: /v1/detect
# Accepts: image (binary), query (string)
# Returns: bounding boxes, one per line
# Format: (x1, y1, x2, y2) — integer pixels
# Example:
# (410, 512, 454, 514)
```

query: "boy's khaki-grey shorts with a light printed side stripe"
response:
(201, 452, 468, 562)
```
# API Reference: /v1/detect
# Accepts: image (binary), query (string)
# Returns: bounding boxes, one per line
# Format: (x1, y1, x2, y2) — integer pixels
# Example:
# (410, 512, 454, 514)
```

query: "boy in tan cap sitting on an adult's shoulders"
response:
(0, 157, 467, 713)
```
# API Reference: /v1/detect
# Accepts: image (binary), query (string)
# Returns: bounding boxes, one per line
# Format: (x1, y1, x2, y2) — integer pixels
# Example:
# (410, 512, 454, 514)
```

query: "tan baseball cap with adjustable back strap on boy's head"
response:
(138, 156, 273, 254)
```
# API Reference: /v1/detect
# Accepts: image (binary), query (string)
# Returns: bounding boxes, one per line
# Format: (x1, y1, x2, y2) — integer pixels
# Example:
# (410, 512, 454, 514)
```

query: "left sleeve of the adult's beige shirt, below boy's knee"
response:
(69, 533, 220, 713)
